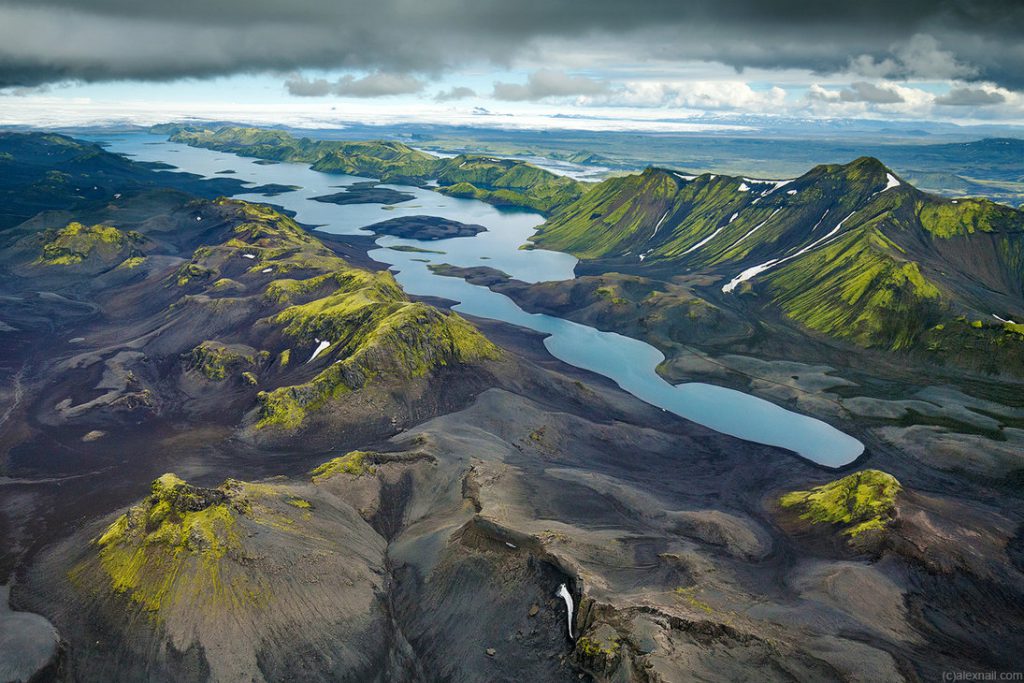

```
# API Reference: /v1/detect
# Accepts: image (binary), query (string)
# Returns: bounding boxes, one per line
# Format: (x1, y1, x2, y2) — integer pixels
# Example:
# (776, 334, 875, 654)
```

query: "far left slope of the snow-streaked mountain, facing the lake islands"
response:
(535, 158, 905, 266)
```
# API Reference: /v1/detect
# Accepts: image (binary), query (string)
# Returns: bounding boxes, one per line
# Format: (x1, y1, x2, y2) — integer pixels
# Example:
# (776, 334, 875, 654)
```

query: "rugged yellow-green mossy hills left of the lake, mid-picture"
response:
(168, 200, 500, 429)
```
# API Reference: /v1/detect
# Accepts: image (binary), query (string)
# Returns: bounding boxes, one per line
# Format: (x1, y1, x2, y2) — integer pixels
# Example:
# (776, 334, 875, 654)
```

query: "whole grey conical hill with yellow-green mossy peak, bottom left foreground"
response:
(47, 474, 388, 681)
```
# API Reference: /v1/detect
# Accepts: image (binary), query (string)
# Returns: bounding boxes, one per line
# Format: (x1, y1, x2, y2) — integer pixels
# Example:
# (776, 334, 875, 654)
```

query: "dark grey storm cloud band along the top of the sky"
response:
(0, 0, 1024, 88)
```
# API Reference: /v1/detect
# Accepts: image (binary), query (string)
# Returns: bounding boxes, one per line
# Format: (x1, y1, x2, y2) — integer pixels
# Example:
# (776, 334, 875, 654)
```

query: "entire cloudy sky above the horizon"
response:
(0, 0, 1024, 128)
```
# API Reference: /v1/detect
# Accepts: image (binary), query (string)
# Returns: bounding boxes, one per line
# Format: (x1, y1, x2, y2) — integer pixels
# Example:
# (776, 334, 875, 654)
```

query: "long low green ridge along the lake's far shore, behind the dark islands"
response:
(171, 127, 584, 213)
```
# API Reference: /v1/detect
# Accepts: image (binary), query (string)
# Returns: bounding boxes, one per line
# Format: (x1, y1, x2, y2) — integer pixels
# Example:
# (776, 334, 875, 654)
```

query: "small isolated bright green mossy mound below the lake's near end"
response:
(779, 470, 902, 538)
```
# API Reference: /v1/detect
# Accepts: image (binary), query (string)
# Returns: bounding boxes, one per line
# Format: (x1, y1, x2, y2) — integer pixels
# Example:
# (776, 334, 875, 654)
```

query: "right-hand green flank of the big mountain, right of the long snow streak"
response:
(751, 187, 1024, 352)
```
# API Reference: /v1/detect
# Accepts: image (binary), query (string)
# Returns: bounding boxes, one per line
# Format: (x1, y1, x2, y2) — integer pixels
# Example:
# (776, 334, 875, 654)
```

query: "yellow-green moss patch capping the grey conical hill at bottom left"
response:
(84, 474, 325, 622)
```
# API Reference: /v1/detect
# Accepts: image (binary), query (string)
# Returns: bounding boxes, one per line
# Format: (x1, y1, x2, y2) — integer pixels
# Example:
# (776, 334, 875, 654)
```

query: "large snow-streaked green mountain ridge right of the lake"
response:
(536, 158, 1024, 371)
